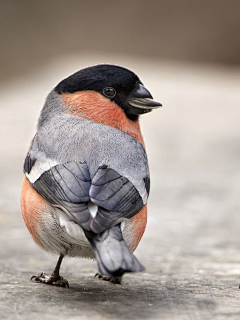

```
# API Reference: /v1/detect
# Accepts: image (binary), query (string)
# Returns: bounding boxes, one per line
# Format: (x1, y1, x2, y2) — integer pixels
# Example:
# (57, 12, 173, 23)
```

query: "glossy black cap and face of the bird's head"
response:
(54, 64, 162, 121)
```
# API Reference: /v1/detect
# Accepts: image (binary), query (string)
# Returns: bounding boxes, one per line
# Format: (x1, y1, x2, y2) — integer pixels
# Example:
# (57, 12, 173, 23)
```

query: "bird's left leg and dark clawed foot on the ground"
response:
(31, 254, 69, 288)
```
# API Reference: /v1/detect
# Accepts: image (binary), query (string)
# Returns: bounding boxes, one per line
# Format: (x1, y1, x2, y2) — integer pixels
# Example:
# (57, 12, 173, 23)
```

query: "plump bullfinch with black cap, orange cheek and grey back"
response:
(21, 64, 162, 287)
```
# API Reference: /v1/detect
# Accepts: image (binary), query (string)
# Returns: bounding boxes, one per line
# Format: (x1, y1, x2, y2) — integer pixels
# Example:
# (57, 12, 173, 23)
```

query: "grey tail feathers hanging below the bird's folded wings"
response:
(85, 225, 144, 277)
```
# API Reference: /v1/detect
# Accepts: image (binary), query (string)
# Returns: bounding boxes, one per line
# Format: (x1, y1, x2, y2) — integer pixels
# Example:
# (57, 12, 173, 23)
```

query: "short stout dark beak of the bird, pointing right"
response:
(128, 84, 162, 115)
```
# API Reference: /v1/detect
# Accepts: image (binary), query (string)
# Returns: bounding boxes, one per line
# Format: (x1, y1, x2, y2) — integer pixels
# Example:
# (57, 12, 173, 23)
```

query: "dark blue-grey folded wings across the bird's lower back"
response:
(28, 160, 149, 234)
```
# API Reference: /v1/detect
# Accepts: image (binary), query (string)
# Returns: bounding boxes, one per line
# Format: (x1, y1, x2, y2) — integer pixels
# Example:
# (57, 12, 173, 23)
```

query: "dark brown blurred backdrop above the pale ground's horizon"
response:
(0, 0, 240, 81)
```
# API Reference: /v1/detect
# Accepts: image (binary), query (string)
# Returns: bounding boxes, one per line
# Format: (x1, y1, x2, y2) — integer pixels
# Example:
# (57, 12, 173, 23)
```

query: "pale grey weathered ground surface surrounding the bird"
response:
(0, 54, 240, 320)
